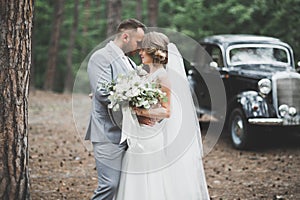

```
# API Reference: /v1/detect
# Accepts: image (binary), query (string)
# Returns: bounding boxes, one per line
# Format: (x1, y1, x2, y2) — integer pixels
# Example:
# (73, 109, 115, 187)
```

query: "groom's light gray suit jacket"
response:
(85, 42, 133, 144)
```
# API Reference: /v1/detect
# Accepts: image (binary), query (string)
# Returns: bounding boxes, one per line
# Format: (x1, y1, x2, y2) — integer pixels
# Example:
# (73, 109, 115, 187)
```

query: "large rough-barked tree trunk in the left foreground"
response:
(0, 0, 33, 200)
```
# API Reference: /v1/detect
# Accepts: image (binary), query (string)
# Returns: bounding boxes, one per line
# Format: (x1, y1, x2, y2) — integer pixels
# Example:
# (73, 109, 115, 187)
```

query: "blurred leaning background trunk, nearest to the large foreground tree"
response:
(44, 0, 64, 90)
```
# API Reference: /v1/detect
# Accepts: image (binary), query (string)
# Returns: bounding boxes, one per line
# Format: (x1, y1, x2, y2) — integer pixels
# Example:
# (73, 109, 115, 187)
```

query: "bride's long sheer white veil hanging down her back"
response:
(164, 43, 209, 200)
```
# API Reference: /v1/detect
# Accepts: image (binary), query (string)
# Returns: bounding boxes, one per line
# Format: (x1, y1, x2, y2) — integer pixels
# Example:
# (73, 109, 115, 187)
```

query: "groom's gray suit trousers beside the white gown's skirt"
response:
(92, 142, 127, 200)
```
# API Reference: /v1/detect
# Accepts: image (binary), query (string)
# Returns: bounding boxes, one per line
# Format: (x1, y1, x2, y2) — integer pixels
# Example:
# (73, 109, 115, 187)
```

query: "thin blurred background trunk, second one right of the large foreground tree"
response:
(64, 0, 79, 93)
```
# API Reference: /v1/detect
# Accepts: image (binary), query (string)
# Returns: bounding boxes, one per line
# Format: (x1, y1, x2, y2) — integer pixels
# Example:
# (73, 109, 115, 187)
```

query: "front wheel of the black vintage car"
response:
(229, 108, 251, 149)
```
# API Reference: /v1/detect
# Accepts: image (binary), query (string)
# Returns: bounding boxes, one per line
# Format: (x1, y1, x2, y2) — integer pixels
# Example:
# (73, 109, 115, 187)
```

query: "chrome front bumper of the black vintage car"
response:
(248, 118, 300, 126)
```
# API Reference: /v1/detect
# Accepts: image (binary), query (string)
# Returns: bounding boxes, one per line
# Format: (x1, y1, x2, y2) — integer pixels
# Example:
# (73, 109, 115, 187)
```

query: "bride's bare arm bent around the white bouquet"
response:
(134, 77, 171, 120)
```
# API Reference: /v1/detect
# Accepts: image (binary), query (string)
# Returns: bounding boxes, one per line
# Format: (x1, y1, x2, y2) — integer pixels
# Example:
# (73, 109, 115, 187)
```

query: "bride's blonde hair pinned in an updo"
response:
(142, 31, 170, 65)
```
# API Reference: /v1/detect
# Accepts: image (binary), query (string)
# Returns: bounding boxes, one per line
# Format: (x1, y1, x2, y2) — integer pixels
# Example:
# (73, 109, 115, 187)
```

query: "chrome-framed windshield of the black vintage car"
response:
(227, 44, 291, 66)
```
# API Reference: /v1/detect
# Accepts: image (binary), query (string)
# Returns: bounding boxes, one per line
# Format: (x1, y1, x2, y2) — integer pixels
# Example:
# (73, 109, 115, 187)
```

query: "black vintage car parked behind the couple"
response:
(187, 35, 300, 149)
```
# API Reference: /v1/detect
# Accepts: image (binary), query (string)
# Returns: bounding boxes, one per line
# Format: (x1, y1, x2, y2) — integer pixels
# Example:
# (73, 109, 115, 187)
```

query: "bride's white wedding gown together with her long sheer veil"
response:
(115, 44, 209, 200)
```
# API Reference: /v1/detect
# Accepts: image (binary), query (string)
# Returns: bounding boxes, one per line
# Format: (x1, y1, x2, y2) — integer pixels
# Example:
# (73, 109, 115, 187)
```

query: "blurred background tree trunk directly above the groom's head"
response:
(106, 0, 122, 37)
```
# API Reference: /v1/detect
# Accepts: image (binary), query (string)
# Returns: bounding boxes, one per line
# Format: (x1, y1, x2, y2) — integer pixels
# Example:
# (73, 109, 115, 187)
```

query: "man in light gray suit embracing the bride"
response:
(85, 19, 146, 200)
